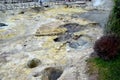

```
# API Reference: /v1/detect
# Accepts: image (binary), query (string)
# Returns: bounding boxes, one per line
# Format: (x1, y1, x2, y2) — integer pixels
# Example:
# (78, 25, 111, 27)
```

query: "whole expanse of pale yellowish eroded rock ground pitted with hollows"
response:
(0, 3, 111, 80)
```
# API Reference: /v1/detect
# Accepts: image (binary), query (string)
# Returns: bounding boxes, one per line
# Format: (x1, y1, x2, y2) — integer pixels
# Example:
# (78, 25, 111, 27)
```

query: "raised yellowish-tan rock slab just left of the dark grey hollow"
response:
(35, 22, 67, 36)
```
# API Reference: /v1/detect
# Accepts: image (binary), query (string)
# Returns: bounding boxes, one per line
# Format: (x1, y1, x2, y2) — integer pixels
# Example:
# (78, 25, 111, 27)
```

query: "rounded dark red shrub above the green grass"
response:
(94, 35, 120, 60)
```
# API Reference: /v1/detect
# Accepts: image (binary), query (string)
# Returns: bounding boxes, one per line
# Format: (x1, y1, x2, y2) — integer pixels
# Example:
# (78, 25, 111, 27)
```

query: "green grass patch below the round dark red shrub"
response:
(88, 57, 120, 80)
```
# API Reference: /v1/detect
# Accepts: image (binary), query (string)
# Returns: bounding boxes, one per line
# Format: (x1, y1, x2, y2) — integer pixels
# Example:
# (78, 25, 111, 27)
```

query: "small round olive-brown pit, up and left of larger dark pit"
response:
(27, 58, 41, 68)
